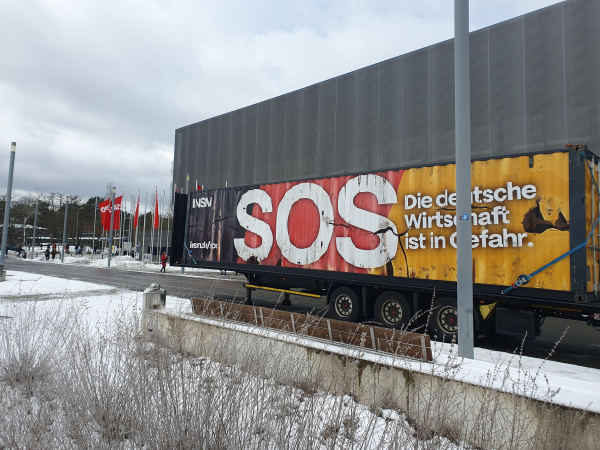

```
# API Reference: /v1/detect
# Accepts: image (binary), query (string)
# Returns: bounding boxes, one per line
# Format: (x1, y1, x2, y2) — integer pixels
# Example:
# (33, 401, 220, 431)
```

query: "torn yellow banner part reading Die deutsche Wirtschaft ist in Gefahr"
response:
(373, 152, 570, 290)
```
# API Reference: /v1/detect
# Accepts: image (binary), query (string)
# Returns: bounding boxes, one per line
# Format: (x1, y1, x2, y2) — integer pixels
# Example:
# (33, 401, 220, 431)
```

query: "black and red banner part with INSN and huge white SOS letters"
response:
(186, 171, 403, 273)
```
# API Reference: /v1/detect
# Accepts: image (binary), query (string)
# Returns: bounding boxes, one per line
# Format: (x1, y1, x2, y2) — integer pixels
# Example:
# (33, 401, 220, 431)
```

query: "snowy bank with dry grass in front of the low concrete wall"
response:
(0, 271, 471, 450)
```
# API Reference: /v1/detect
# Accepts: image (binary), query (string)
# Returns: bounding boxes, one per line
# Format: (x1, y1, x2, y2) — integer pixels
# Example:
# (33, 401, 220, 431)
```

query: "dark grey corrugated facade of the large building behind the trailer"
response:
(174, 0, 600, 192)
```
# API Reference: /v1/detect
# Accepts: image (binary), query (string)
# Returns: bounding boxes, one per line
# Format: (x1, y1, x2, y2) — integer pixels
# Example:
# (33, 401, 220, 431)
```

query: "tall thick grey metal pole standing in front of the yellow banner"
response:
(454, 0, 474, 359)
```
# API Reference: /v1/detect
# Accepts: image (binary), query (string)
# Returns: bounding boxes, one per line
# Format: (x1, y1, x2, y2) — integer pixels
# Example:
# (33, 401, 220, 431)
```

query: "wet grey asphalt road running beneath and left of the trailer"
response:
(5, 257, 600, 369)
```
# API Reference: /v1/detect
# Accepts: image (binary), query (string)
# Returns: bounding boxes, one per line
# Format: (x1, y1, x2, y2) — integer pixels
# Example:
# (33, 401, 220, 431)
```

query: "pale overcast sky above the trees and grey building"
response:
(0, 0, 558, 204)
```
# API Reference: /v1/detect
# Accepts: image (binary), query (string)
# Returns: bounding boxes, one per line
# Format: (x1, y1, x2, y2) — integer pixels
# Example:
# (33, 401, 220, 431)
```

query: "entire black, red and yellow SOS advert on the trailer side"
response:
(186, 152, 591, 291)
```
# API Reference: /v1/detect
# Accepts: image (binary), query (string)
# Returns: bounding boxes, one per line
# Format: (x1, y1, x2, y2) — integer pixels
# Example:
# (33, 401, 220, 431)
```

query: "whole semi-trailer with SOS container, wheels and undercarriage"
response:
(171, 146, 600, 339)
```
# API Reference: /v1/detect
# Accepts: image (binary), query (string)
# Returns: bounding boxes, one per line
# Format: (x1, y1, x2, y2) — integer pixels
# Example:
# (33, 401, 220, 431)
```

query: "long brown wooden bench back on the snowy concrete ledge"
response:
(191, 298, 433, 362)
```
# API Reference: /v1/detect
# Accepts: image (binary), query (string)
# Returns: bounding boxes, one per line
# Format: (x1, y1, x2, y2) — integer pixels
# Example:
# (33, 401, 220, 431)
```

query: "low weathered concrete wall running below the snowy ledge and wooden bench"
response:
(142, 310, 600, 450)
